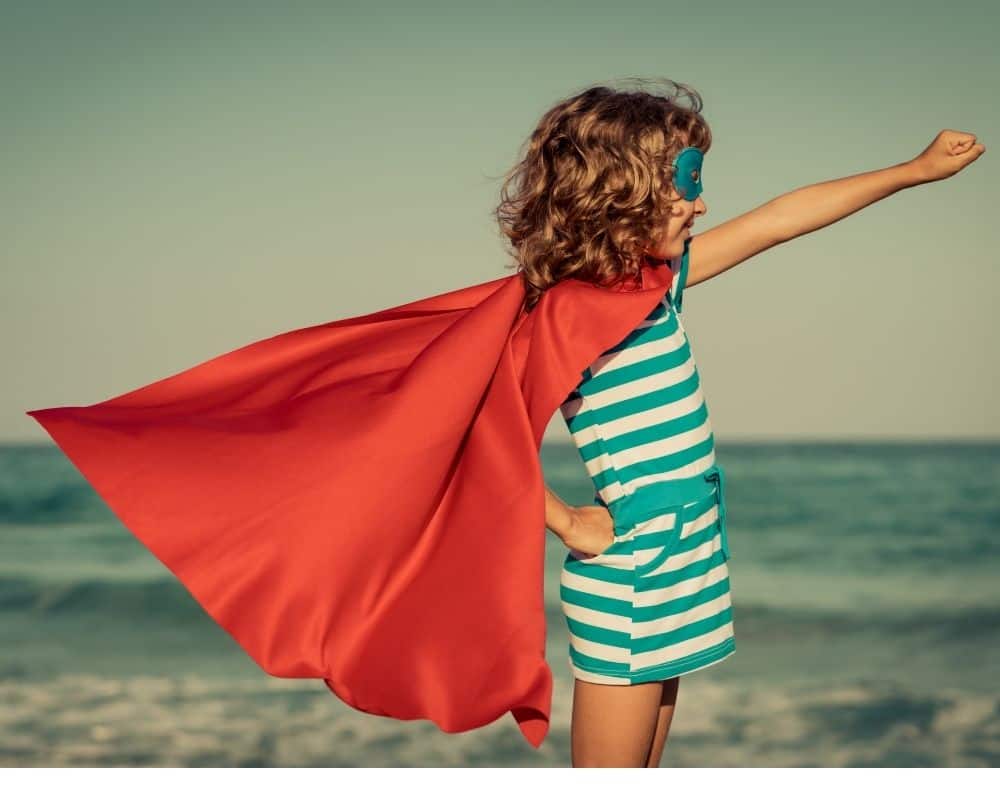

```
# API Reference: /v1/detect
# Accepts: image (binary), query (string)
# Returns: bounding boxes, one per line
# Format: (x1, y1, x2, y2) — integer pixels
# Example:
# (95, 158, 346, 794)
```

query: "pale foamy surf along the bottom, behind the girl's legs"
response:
(0, 674, 1000, 767)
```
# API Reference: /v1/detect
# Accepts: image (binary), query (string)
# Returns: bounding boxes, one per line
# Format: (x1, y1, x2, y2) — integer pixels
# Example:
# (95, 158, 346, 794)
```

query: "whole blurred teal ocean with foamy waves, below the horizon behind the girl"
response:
(0, 442, 1000, 767)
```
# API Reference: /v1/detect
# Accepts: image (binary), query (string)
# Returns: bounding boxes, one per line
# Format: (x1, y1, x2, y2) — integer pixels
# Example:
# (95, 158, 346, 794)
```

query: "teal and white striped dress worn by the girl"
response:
(560, 239, 735, 684)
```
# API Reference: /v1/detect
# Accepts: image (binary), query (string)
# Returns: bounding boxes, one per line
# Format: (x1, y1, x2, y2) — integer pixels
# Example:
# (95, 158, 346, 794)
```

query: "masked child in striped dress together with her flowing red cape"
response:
(27, 78, 983, 765)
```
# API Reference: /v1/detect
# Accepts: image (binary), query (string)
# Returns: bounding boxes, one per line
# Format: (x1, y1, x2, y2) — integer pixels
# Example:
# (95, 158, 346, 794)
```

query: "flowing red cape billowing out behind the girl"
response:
(27, 264, 672, 747)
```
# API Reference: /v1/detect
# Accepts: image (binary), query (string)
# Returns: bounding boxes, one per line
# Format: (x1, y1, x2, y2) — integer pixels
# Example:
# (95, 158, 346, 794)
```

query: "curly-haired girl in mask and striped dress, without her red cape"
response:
(498, 82, 985, 766)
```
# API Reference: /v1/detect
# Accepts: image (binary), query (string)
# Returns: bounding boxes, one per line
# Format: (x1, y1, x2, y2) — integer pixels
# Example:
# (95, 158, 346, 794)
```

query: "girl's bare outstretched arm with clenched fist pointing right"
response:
(686, 130, 986, 286)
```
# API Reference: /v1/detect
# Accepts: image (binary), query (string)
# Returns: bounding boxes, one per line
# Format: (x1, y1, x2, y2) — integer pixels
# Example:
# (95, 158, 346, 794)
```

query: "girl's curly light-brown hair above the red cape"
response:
(494, 78, 712, 310)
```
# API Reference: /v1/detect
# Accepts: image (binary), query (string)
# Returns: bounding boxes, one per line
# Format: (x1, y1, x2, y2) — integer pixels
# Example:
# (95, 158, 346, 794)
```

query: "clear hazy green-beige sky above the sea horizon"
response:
(0, 0, 1000, 442)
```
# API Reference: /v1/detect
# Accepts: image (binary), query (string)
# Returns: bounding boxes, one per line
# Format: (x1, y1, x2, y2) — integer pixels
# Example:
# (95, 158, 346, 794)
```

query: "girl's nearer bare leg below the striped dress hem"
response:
(570, 678, 672, 767)
